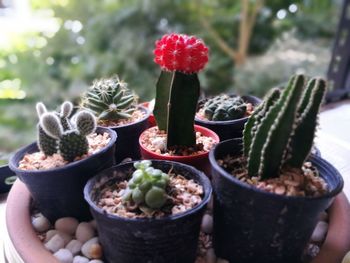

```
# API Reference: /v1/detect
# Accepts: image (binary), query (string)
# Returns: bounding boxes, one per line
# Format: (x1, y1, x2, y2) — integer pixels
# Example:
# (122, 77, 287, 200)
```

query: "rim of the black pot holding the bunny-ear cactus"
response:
(9, 127, 118, 175)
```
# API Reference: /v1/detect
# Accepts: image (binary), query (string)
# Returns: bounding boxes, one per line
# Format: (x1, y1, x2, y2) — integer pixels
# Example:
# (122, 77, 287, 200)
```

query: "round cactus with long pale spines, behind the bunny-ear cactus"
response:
(81, 76, 137, 120)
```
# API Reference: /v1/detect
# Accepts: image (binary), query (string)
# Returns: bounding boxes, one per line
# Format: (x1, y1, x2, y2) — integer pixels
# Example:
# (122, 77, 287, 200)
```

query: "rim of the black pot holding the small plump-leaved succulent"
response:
(84, 159, 213, 222)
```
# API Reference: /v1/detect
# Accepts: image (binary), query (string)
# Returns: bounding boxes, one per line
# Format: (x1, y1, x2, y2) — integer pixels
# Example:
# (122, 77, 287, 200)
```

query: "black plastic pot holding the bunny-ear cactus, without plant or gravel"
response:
(10, 128, 117, 222)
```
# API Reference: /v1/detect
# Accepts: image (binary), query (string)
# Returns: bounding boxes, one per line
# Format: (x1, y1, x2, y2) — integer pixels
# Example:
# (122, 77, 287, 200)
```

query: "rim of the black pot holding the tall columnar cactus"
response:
(209, 138, 344, 201)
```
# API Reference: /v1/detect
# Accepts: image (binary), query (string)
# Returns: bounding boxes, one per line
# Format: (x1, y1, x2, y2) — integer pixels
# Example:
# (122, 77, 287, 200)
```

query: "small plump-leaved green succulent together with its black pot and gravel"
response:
(84, 160, 211, 263)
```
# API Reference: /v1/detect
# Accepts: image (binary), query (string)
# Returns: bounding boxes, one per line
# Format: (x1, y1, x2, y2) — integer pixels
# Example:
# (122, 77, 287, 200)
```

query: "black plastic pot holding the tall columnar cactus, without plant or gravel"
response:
(209, 139, 343, 263)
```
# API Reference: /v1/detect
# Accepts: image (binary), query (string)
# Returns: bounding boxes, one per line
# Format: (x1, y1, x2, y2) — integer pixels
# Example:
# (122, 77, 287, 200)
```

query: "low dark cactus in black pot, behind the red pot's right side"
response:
(195, 94, 261, 141)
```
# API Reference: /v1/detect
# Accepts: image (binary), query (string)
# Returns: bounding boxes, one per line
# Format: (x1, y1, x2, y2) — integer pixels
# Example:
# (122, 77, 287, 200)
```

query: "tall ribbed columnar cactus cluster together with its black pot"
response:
(209, 75, 343, 263)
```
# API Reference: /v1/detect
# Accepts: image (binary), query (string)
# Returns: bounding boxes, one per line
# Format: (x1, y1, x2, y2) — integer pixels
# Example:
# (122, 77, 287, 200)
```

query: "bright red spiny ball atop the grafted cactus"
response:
(154, 34, 208, 74)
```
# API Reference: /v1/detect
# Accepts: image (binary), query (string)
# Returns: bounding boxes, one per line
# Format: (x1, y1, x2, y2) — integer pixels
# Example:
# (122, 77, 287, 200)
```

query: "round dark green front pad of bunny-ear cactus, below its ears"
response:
(58, 130, 89, 162)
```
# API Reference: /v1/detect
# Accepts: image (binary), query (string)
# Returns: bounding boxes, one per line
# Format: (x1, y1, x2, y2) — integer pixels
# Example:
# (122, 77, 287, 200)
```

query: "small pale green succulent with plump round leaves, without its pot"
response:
(123, 160, 169, 209)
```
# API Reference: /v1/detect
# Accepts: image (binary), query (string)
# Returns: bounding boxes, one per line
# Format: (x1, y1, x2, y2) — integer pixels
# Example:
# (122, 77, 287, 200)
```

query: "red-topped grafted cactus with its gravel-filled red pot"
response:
(139, 34, 219, 175)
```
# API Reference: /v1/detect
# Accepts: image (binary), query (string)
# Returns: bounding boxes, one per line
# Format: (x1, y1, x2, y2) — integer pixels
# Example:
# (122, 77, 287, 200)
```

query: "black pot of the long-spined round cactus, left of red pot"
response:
(108, 106, 151, 164)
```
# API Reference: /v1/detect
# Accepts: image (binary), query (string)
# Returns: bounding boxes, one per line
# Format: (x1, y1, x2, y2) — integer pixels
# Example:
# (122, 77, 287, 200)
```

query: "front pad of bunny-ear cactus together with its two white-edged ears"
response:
(40, 111, 96, 162)
